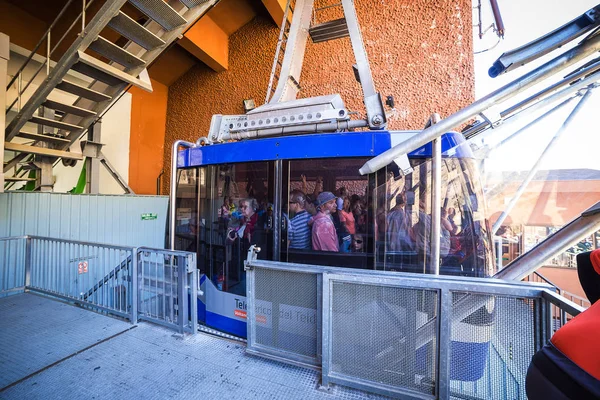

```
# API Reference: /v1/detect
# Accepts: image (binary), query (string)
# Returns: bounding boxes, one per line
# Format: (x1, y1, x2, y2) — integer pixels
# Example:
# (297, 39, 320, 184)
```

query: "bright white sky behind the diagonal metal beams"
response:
(473, 0, 600, 171)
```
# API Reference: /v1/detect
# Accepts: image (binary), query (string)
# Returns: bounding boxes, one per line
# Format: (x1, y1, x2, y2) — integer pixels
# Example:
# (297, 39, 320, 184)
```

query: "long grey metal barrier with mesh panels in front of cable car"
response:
(246, 248, 582, 399)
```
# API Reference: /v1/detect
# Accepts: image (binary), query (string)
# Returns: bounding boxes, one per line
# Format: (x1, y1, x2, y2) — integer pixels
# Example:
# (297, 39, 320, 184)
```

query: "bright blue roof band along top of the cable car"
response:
(177, 131, 473, 168)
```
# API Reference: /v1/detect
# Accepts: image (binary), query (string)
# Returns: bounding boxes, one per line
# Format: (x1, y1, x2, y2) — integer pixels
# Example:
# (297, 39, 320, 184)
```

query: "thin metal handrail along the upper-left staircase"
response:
(5, 0, 94, 114)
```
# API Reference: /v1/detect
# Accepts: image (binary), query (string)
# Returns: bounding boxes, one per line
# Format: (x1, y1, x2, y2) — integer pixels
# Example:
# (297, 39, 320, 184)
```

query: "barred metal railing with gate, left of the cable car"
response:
(0, 236, 198, 333)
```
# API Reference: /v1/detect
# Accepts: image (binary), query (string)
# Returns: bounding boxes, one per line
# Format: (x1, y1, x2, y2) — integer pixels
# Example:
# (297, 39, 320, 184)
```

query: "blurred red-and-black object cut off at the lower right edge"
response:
(525, 249, 600, 400)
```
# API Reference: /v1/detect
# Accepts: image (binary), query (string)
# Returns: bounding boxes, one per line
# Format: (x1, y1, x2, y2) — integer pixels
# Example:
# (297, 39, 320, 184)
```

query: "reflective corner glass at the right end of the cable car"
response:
(376, 157, 494, 276)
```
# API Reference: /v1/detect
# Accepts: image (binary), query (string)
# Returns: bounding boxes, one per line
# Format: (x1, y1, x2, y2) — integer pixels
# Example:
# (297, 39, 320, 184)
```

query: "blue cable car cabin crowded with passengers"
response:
(175, 131, 495, 337)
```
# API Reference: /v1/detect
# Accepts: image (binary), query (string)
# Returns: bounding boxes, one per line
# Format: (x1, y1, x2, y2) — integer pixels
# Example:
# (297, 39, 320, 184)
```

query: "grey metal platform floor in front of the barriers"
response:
(0, 294, 380, 400)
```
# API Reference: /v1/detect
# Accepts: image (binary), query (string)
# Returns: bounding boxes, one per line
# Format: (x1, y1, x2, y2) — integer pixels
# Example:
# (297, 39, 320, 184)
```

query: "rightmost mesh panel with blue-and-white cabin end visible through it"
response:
(450, 292, 535, 399)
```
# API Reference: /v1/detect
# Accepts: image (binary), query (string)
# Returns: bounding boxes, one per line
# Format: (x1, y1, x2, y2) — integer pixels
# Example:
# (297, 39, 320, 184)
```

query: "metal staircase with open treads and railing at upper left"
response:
(3, 0, 218, 189)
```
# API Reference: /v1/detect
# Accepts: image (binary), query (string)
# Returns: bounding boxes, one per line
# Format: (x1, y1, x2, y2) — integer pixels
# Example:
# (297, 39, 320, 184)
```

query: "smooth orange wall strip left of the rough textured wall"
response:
(129, 80, 169, 194)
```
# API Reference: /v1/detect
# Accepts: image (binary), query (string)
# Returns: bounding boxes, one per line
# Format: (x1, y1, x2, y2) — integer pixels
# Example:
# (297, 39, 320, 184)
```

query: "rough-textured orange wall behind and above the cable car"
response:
(163, 0, 474, 191)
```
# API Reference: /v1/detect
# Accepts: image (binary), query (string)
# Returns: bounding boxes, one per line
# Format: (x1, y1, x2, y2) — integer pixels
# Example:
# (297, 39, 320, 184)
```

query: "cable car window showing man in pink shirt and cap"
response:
(281, 158, 374, 268)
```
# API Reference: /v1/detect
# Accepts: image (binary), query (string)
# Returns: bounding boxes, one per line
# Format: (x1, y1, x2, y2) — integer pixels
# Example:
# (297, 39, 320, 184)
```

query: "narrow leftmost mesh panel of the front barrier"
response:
(255, 268, 321, 360)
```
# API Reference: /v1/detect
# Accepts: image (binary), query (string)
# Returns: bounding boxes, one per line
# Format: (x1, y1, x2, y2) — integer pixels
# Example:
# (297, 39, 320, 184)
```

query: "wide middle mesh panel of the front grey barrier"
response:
(330, 282, 439, 394)
